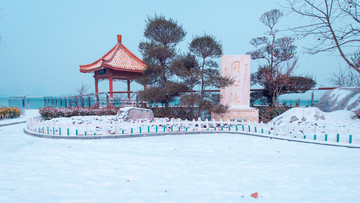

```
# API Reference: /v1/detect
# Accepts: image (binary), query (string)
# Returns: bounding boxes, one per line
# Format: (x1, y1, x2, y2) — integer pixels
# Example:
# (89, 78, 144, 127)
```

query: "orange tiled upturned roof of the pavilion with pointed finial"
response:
(80, 35, 146, 73)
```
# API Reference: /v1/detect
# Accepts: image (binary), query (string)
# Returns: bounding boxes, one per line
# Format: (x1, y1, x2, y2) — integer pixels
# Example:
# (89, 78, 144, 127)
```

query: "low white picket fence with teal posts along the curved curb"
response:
(26, 117, 360, 145)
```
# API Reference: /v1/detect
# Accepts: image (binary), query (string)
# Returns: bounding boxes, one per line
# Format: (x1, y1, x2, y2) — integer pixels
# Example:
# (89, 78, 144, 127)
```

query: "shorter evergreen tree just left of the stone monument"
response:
(175, 34, 233, 118)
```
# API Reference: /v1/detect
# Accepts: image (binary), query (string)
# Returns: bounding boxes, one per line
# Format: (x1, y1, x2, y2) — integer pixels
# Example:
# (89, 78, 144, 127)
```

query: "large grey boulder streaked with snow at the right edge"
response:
(316, 87, 360, 115)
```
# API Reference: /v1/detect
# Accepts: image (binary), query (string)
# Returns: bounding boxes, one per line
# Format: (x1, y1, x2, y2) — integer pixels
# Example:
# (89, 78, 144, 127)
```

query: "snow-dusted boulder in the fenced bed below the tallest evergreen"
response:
(116, 107, 154, 121)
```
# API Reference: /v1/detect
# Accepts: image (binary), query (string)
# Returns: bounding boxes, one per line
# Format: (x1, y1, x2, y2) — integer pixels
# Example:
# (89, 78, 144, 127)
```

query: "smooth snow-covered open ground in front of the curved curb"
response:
(0, 124, 360, 202)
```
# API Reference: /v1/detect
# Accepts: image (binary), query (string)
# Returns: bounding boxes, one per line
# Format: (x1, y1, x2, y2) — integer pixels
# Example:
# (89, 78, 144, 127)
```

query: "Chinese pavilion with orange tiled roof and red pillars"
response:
(80, 35, 146, 100)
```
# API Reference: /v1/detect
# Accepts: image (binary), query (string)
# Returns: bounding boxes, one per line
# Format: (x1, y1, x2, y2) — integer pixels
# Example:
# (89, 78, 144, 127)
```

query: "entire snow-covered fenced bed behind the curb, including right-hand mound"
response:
(23, 107, 360, 147)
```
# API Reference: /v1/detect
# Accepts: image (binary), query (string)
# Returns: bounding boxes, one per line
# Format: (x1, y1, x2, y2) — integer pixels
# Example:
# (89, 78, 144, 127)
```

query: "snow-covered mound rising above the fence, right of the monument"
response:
(270, 107, 359, 125)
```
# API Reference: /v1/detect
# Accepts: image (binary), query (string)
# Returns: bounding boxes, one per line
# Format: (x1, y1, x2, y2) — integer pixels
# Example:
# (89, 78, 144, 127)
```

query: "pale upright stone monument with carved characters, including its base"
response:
(211, 55, 259, 122)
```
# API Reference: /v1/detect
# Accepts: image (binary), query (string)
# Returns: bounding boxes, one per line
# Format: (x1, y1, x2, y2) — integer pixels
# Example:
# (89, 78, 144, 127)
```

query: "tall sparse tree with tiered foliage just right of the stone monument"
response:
(249, 9, 316, 106)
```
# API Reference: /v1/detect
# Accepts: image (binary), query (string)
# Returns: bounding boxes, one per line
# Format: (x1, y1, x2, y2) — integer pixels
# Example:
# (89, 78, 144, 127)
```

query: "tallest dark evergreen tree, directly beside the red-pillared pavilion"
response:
(137, 15, 187, 109)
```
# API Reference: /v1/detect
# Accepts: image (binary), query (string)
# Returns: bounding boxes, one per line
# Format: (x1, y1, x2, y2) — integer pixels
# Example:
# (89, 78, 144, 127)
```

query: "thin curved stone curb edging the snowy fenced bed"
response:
(24, 128, 360, 149)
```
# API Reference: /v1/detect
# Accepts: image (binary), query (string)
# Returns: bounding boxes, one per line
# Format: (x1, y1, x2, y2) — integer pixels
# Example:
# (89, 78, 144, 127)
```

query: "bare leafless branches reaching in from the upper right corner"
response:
(287, 0, 360, 74)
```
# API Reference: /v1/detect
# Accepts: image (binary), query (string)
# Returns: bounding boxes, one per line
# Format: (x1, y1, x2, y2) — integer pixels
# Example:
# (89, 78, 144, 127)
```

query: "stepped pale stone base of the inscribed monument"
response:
(211, 107, 259, 122)
